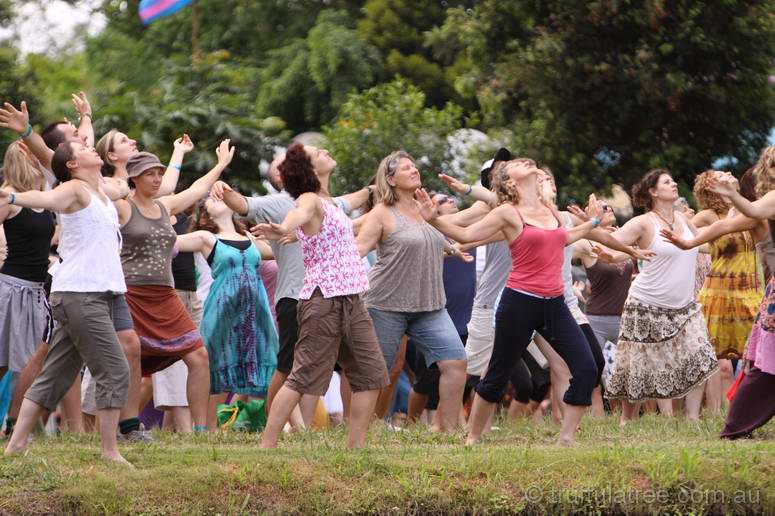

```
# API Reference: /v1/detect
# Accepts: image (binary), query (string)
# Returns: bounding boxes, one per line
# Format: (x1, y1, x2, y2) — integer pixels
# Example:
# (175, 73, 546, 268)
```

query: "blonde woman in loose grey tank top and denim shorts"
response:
(358, 151, 466, 432)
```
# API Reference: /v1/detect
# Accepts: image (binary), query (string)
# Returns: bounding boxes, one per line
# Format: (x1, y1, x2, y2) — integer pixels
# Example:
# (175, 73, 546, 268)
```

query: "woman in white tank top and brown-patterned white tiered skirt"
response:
(607, 169, 718, 423)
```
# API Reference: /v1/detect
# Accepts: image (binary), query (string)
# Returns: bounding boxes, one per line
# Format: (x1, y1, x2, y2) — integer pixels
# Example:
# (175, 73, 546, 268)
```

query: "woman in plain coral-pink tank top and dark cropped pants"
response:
(417, 158, 610, 444)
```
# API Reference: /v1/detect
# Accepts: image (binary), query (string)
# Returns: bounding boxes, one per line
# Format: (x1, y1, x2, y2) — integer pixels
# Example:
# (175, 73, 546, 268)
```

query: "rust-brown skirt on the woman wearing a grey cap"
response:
(126, 285, 203, 376)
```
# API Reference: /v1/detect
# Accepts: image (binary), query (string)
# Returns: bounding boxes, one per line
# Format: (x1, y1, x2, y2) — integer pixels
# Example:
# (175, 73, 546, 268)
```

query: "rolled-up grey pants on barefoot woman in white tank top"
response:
(25, 292, 129, 411)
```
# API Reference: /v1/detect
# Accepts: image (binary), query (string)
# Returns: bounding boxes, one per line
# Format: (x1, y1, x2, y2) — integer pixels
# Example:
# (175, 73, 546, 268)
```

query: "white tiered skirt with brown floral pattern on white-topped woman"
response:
(606, 297, 718, 401)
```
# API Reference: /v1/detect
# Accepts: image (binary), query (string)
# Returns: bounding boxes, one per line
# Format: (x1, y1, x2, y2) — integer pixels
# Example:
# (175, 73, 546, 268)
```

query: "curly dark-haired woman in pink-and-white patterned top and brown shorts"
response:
(257, 144, 390, 448)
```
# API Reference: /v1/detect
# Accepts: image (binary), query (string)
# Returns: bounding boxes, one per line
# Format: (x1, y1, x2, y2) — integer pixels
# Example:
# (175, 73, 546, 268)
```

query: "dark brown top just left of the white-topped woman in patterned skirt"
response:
(586, 260, 634, 315)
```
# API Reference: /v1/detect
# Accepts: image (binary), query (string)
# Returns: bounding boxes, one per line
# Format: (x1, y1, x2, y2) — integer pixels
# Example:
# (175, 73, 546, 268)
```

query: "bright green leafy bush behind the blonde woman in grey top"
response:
(324, 78, 462, 192)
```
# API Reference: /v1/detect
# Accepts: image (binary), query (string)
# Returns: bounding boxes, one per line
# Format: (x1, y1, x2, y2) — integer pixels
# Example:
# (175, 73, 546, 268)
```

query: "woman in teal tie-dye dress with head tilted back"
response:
(177, 199, 278, 424)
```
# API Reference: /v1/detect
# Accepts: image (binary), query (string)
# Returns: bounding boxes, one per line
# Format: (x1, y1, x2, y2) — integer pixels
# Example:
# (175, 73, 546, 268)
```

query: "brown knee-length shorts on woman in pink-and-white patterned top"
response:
(285, 289, 390, 396)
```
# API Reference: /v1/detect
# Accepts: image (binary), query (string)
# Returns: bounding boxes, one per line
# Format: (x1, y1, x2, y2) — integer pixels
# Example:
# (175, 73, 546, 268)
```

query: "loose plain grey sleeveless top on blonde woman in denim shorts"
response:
(364, 207, 447, 312)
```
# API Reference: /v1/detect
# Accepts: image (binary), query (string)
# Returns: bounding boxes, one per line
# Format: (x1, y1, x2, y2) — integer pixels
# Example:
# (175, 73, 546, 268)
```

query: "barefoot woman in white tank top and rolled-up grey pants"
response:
(0, 141, 135, 464)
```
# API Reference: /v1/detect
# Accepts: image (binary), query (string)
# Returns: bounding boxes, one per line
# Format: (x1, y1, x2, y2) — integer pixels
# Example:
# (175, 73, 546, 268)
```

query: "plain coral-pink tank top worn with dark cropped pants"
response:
(506, 207, 568, 297)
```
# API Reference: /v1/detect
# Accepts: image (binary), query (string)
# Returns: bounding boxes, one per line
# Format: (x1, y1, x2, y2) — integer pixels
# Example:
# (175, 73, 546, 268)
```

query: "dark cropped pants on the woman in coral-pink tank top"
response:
(476, 288, 598, 406)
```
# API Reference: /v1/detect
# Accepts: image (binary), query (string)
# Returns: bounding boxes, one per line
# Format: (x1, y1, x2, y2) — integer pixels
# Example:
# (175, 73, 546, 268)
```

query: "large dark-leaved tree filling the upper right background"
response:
(433, 0, 775, 202)
